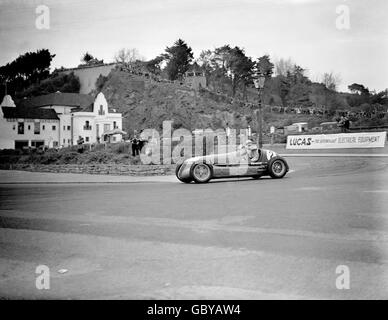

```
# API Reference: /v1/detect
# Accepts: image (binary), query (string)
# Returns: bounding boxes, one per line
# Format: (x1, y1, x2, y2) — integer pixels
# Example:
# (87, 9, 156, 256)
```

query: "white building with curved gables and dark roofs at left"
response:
(0, 92, 122, 149)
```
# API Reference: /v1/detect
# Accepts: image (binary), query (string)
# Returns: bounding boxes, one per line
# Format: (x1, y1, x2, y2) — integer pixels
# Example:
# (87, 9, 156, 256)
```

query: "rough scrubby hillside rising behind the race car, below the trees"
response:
(95, 69, 388, 135)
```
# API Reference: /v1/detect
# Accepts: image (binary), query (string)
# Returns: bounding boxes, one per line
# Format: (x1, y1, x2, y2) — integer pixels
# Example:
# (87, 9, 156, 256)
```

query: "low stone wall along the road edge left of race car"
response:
(0, 164, 175, 176)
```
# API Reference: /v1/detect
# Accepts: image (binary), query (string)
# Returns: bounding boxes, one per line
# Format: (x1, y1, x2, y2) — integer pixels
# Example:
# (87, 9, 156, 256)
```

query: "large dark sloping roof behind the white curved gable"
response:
(19, 92, 94, 110)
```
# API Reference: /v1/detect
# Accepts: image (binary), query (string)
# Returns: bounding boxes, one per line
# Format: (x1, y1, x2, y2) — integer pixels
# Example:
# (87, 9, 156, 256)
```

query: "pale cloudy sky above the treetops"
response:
(0, 0, 388, 91)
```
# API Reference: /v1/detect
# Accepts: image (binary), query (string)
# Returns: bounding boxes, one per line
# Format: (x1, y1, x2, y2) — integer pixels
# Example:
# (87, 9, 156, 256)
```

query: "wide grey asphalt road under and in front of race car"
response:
(0, 157, 388, 299)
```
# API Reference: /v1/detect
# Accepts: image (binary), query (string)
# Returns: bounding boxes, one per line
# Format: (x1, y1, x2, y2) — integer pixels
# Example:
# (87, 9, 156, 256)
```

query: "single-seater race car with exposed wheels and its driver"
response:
(175, 140, 289, 183)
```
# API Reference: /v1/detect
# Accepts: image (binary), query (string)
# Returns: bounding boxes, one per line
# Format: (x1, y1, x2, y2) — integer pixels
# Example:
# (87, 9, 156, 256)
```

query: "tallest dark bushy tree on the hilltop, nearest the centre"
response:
(164, 39, 194, 80)
